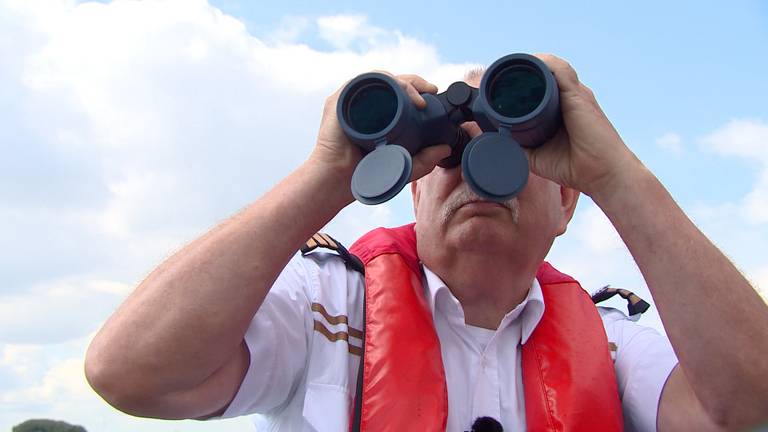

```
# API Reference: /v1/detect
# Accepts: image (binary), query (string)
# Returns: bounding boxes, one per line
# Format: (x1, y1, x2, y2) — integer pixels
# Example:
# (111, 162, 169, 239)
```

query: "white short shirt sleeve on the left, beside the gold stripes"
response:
(222, 256, 314, 418)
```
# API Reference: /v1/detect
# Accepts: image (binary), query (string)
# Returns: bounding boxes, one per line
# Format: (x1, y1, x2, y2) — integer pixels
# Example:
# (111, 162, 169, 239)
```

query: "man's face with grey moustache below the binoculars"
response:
(413, 122, 567, 265)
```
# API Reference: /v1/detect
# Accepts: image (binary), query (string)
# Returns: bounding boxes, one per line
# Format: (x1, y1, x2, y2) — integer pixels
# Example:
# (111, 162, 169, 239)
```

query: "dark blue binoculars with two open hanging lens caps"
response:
(336, 54, 562, 204)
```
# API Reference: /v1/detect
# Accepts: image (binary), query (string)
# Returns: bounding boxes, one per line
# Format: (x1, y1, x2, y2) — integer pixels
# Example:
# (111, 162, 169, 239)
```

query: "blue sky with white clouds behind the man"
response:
(0, 0, 768, 432)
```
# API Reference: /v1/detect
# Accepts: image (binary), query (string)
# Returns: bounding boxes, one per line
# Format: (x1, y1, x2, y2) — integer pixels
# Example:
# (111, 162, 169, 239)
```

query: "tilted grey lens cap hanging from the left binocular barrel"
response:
(352, 144, 413, 204)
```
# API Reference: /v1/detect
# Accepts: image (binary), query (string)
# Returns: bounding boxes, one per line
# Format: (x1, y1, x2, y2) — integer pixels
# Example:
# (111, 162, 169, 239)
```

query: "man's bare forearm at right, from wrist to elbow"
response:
(592, 163, 768, 427)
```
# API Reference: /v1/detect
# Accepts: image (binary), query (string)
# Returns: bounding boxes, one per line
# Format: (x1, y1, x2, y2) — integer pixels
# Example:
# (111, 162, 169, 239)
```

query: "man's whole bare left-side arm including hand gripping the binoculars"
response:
(85, 69, 450, 418)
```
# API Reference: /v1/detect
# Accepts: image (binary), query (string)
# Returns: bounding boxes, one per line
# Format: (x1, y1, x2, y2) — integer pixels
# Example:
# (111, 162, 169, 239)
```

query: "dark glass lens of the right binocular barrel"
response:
(488, 64, 547, 117)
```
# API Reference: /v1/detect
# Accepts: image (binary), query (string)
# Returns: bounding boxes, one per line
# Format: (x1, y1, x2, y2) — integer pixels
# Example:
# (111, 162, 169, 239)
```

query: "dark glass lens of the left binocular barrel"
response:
(345, 81, 397, 134)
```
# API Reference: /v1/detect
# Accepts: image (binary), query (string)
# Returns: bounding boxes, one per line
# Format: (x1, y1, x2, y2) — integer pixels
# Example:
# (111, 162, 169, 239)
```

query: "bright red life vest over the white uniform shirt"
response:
(350, 224, 623, 431)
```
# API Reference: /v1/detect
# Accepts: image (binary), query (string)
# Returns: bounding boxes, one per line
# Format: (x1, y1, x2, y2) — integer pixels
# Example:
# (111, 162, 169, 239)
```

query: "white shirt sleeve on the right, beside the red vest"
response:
(598, 307, 677, 432)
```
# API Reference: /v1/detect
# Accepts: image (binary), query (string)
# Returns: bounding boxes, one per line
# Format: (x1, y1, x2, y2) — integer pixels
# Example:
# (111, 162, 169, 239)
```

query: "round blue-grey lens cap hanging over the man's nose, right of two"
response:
(461, 132, 528, 202)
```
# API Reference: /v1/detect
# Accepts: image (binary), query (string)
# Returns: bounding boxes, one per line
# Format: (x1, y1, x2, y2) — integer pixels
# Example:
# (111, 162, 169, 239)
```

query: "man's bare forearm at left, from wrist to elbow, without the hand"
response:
(88, 158, 352, 393)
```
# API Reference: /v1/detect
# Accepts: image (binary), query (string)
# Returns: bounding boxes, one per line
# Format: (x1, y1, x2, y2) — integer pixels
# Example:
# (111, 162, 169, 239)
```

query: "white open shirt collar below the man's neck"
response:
(423, 266, 544, 344)
